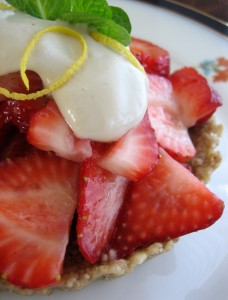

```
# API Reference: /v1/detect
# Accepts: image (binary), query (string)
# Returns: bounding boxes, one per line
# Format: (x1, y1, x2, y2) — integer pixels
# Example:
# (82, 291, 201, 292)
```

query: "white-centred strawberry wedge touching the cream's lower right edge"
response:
(99, 113, 159, 181)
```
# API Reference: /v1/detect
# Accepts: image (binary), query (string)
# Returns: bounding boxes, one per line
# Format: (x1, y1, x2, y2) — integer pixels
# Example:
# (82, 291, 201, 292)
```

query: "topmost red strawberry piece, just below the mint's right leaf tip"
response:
(130, 38, 170, 77)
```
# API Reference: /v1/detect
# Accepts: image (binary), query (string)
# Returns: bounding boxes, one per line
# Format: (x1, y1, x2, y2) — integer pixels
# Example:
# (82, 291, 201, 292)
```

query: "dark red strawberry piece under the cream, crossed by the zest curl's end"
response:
(0, 70, 43, 101)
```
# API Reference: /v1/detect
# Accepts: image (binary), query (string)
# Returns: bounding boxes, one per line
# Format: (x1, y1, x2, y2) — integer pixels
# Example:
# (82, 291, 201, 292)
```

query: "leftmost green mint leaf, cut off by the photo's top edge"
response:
(7, 0, 71, 20)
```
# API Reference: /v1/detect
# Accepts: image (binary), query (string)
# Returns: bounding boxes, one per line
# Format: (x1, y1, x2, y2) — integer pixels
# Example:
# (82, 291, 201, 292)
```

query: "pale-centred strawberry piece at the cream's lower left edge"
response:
(27, 100, 92, 162)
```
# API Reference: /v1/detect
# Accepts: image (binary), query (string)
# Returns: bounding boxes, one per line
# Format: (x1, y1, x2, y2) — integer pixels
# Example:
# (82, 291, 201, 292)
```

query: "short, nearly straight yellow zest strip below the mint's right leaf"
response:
(90, 31, 145, 73)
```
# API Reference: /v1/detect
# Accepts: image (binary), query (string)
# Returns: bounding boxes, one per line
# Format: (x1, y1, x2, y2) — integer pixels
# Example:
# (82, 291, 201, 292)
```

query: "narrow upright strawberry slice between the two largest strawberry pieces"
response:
(77, 147, 127, 263)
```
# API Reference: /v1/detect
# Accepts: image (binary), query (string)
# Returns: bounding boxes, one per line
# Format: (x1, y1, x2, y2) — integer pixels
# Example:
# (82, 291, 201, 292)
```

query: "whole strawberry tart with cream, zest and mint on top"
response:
(0, 0, 224, 294)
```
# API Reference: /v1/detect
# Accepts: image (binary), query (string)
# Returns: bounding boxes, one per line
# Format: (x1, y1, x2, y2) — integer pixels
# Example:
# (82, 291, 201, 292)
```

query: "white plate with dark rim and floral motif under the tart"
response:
(0, 0, 228, 300)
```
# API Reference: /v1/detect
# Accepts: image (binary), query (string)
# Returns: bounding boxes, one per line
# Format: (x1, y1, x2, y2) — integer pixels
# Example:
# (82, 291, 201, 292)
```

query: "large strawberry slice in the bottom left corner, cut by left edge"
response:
(0, 153, 79, 288)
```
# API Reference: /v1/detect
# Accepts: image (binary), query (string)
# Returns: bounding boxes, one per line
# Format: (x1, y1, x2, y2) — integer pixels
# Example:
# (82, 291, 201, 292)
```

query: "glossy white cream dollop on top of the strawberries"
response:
(0, 11, 147, 142)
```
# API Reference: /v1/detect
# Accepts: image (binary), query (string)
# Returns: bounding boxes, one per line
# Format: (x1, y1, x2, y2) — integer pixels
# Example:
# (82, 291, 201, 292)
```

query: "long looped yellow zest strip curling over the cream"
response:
(0, 26, 87, 100)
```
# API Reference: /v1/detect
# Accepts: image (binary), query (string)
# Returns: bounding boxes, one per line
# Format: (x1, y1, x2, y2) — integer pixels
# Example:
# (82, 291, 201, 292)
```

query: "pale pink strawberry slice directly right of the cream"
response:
(148, 75, 195, 162)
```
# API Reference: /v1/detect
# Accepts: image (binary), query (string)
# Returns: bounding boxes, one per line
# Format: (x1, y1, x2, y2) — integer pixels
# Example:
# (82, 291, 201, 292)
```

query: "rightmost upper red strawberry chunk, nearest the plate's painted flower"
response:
(170, 67, 222, 128)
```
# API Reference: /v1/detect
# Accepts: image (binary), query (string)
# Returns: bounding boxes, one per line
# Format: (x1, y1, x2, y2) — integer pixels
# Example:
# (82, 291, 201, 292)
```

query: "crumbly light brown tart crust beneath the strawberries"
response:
(0, 118, 222, 295)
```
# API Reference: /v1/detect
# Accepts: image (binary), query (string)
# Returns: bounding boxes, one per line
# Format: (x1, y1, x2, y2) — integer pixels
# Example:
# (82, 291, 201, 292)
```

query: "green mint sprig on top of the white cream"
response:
(6, 0, 131, 46)
